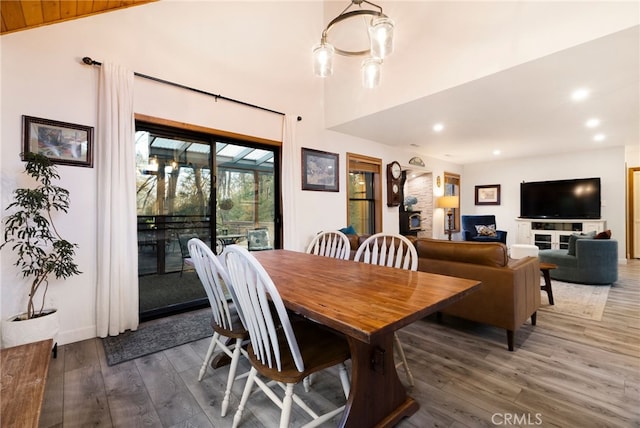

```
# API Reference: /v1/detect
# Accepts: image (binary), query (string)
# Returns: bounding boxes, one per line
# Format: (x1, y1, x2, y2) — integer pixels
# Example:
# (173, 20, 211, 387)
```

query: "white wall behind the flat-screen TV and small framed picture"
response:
(460, 147, 626, 259)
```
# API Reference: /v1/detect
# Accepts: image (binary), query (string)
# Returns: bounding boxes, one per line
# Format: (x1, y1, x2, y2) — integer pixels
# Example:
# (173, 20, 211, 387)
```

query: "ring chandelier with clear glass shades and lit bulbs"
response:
(313, 0, 394, 88)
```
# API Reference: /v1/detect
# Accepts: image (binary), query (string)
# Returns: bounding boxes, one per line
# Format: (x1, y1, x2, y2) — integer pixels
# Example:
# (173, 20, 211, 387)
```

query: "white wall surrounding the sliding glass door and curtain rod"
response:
(0, 1, 424, 344)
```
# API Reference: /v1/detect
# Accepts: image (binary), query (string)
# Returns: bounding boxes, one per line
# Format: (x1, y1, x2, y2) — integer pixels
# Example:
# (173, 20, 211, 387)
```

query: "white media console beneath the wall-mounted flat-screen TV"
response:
(516, 218, 607, 250)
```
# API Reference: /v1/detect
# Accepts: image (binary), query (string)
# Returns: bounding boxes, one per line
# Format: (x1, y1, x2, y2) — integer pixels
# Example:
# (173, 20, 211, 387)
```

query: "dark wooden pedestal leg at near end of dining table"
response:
(339, 332, 420, 427)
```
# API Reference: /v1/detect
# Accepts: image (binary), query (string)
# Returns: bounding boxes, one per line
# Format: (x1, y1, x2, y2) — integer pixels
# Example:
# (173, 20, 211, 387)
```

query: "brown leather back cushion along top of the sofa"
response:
(415, 238, 509, 267)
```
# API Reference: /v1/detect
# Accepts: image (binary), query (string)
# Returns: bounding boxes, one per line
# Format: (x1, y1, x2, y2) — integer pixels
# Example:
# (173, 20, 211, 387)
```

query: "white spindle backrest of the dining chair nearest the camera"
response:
(224, 245, 304, 372)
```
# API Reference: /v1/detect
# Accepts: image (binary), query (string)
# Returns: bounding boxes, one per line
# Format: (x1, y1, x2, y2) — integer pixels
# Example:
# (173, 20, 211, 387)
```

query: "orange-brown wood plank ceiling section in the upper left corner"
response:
(0, 0, 156, 34)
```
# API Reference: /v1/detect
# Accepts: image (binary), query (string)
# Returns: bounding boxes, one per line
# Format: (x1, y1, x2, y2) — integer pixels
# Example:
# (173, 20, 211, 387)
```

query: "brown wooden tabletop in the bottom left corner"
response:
(0, 339, 53, 427)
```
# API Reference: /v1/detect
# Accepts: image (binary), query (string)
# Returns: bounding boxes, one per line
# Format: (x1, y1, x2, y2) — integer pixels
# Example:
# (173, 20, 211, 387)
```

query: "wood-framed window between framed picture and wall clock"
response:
(347, 153, 382, 235)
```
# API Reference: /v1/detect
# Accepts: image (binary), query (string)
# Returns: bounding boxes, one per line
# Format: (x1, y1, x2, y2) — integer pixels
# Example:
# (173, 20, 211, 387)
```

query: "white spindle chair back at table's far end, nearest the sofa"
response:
(354, 233, 418, 270)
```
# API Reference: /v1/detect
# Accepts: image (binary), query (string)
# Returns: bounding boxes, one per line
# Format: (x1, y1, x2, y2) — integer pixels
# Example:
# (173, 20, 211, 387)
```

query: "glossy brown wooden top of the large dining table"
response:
(253, 250, 480, 343)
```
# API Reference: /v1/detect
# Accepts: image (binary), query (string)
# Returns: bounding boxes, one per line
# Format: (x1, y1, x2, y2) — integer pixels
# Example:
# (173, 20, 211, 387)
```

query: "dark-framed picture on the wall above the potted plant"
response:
(22, 116, 93, 168)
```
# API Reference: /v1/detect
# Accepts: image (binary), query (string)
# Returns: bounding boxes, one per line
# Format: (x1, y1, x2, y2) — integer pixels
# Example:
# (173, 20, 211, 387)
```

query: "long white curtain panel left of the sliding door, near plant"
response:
(96, 63, 138, 337)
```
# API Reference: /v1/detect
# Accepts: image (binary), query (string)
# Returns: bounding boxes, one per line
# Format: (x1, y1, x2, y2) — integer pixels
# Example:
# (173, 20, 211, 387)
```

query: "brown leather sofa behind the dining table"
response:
(349, 235, 540, 351)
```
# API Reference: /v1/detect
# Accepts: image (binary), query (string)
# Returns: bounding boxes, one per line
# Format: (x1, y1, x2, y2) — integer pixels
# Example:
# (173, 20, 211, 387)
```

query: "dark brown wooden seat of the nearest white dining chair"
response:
(247, 319, 351, 383)
